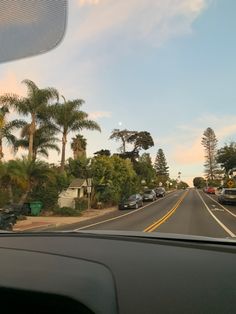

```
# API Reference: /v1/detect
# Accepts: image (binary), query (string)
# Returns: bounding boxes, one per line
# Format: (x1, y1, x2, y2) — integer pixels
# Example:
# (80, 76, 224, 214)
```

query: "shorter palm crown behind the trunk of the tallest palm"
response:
(15, 124, 60, 160)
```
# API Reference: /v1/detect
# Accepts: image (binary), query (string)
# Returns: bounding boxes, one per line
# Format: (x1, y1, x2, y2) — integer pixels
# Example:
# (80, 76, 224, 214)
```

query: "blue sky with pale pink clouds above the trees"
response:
(0, 0, 236, 184)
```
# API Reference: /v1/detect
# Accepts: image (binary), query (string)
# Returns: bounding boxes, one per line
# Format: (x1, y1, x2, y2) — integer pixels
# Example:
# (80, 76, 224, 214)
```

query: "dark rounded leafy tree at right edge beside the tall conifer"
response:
(216, 142, 236, 173)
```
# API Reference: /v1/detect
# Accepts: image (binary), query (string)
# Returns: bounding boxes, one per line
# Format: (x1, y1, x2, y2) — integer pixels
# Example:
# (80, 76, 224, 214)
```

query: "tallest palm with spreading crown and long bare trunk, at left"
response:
(0, 79, 59, 160)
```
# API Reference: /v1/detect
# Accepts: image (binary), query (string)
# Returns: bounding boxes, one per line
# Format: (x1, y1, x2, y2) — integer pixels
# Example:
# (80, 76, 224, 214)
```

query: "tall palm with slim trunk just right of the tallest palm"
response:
(51, 96, 101, 171)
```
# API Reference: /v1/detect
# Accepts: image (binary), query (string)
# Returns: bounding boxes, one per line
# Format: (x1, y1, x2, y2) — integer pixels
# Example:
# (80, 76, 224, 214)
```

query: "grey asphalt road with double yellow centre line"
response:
(48, 189, 236, 238)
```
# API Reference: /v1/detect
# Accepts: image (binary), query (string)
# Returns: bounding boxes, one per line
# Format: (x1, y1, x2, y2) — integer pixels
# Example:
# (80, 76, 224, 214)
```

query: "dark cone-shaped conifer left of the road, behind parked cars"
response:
(154, 148, 169, 185)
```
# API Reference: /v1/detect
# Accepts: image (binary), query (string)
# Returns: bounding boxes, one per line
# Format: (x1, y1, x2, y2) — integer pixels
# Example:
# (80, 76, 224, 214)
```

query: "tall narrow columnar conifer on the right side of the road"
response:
(202, 128, 218, 180)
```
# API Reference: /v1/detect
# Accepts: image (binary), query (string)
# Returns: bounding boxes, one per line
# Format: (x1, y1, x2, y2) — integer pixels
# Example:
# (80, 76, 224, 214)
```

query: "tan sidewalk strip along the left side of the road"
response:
(13, 207, 117, 232)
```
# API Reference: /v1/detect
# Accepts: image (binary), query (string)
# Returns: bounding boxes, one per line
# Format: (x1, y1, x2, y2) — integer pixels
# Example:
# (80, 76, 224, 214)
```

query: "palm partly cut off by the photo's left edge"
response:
(0, 106, 26, 161)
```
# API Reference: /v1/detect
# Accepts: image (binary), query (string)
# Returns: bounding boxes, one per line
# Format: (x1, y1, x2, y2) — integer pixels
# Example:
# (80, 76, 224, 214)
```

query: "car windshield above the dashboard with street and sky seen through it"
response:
(0, 0, 236, 238)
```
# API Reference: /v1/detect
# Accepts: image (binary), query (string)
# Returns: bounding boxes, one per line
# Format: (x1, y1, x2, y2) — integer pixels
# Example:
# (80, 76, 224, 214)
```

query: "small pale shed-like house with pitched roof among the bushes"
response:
(58, 179, 87, 208)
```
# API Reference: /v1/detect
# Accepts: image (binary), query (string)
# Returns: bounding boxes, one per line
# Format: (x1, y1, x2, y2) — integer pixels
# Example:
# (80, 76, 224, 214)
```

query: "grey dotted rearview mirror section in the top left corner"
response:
(0, 0, 67, 62)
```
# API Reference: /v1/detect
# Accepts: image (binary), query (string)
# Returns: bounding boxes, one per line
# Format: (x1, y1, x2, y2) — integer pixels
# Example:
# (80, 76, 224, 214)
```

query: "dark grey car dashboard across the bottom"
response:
(0, 231, 236, 314)
